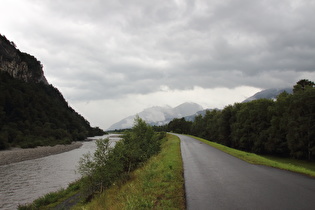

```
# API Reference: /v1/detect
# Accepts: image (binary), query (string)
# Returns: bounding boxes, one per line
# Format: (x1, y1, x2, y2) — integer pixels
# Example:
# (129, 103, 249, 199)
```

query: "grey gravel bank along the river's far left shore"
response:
(0, 142, 82, 166)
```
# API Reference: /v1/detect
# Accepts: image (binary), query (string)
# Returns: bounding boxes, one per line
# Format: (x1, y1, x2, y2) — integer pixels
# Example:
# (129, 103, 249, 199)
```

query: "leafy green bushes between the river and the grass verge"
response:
(79, 117, 165, 196)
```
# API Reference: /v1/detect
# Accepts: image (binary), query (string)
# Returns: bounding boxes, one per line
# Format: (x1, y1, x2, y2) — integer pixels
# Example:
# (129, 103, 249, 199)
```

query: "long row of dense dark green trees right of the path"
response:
(155, 80, 315, 160)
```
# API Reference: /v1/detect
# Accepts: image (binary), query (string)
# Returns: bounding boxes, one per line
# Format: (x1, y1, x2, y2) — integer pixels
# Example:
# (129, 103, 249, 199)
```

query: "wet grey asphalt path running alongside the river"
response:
(176, 134, 315, 210)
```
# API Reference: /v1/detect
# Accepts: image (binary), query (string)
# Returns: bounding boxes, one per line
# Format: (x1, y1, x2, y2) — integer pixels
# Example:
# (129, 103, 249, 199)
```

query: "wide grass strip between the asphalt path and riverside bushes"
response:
(74, 134, 185, 210)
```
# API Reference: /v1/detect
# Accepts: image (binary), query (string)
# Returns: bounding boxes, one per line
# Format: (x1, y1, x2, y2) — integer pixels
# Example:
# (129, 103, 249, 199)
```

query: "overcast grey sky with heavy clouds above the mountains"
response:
(0, 0, 315, 129)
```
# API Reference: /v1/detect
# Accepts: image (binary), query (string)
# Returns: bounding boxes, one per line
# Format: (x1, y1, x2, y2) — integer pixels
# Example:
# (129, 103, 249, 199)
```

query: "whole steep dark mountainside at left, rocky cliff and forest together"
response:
(0, 35, 103, 149)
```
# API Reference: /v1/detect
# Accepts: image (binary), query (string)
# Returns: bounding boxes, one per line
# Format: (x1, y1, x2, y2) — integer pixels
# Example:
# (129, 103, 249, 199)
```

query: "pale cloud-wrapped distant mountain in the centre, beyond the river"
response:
(108, 103, 203, 130)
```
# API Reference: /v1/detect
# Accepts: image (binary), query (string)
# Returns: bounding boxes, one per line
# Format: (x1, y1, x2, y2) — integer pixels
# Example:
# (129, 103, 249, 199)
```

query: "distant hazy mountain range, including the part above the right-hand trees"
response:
(107, 88, 292, 130)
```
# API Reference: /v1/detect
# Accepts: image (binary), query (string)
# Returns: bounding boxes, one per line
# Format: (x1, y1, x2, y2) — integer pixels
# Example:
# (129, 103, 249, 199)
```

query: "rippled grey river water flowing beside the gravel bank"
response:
(0, 135, 119, 210)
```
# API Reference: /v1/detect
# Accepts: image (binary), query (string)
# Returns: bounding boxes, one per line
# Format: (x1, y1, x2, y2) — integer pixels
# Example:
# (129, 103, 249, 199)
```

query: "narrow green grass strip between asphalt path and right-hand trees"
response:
(190, 136, 315, 177)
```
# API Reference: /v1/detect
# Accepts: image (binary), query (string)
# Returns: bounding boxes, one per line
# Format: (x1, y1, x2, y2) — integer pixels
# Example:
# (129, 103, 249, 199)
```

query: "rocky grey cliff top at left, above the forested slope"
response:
(0, 34, 48, 84)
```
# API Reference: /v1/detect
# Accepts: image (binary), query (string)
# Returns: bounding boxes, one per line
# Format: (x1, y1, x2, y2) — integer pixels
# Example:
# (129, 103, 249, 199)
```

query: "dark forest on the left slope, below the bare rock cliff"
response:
(0, 72, 104, 149)
